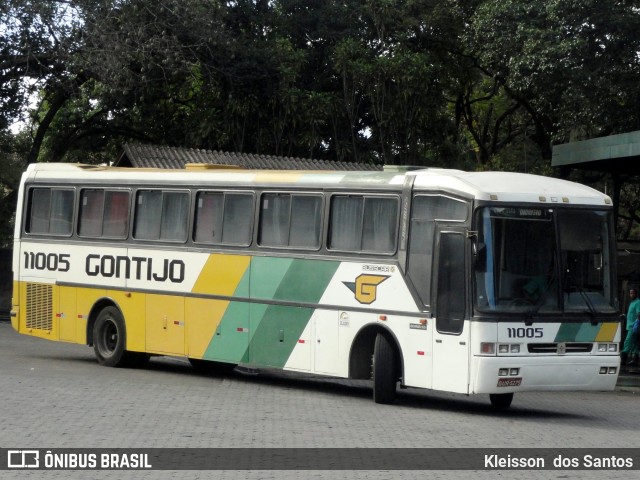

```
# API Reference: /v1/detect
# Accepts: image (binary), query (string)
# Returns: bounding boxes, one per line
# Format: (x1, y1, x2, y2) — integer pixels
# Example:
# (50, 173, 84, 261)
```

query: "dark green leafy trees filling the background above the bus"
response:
(0, 0, 640, 240)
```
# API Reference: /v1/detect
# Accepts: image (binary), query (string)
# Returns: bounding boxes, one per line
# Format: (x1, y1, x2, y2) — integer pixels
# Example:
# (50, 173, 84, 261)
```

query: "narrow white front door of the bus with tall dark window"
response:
(433, 226, 470, 393)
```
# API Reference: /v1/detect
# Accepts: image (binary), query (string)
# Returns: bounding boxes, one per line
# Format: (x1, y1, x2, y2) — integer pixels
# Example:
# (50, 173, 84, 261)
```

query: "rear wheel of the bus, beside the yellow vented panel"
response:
(93, 306, 134, 367)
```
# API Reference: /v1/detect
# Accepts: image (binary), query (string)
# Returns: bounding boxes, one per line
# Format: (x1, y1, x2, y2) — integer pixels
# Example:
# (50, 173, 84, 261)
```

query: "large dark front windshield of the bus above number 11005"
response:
(474, 207, 615, 315)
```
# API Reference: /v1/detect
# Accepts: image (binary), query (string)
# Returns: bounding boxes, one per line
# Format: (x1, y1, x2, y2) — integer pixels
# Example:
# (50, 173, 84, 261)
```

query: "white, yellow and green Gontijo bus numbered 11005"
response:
(11, 164, 621, 409)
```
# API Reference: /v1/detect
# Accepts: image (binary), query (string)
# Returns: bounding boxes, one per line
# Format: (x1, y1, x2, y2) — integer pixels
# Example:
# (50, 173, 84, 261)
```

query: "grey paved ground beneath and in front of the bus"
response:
(0, 322, 640, 480)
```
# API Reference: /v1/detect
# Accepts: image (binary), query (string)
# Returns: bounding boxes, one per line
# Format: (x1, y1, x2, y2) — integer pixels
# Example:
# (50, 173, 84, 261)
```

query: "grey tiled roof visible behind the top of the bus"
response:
(115, 143, 382, 171)
